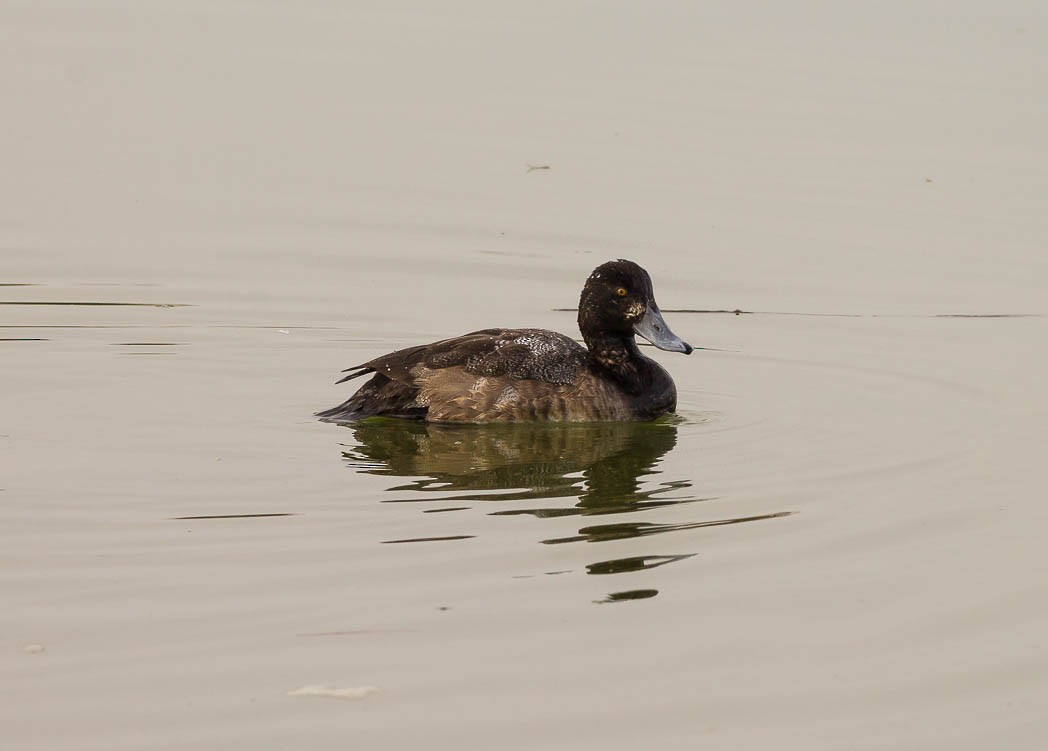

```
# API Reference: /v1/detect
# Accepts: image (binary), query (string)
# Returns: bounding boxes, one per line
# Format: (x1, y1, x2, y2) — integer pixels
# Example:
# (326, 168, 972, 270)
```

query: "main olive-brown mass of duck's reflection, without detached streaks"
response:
(343, 420, 691, 516)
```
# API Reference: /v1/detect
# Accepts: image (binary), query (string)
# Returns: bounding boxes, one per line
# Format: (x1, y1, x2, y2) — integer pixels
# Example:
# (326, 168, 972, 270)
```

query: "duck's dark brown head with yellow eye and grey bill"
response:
(578, 259, 692, 355)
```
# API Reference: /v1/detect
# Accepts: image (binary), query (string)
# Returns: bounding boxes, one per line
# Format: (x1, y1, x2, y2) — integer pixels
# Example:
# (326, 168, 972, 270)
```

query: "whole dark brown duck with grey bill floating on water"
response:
(316, 259, 694, 423)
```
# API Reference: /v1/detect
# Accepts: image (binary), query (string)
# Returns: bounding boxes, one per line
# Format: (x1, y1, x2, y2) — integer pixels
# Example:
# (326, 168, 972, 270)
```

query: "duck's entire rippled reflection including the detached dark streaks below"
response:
(343, 417, 788, 602)
